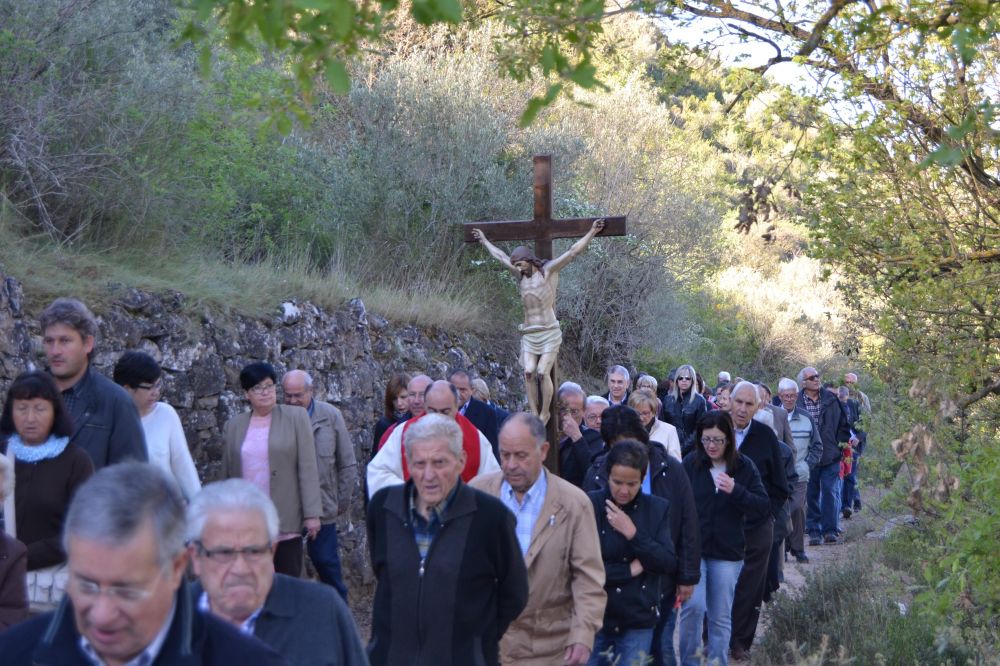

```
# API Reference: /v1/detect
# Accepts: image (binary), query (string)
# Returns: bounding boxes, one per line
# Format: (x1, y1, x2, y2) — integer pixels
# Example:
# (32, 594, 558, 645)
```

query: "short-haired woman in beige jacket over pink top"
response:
(222, 362, 323, 578)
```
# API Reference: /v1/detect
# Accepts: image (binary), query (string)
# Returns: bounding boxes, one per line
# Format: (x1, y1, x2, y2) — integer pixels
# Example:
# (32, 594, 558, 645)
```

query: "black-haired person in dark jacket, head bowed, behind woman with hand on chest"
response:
(583, 405, 701, 664)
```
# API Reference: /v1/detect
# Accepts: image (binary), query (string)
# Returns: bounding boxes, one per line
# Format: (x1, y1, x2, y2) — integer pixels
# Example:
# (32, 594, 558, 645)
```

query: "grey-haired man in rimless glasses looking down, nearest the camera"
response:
(0, 463, 287, 666)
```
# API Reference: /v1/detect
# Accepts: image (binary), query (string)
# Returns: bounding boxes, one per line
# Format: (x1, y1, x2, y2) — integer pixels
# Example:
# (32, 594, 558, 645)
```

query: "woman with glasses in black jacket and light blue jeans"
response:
(680, 411, 771, 666)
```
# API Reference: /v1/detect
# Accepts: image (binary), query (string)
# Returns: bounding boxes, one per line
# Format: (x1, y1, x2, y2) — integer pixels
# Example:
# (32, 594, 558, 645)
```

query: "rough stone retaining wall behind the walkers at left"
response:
(0, 272, 523, 595)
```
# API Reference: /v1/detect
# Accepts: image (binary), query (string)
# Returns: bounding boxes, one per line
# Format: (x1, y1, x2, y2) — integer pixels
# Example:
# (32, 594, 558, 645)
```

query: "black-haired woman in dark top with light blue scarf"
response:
(0, 371, 94, 568)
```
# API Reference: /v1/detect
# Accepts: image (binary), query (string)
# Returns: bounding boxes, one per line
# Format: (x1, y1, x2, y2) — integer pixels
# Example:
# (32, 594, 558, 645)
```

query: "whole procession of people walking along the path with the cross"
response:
(0, 296, 870, 666)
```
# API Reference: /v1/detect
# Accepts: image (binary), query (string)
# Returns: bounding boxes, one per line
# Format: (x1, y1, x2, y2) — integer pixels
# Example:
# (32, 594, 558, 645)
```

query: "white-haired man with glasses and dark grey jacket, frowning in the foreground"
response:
(187, 479, 368, 666)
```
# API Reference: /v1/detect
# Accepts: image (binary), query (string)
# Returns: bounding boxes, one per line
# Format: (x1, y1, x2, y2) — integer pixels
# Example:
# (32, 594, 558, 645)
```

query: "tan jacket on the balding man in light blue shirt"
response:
(469, 472, 607, 666)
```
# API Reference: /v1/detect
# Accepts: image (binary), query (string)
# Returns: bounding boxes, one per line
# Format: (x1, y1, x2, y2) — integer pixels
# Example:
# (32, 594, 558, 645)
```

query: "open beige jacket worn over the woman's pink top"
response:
(222, 405, 323, 533)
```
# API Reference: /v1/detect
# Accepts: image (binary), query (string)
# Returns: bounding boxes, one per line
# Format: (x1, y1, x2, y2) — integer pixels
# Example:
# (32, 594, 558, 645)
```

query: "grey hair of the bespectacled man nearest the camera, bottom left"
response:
(63, 462, 186, 566)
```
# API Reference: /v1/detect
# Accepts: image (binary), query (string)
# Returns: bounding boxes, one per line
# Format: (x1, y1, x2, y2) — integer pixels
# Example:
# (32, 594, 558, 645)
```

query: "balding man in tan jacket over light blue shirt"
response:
(470, 412, 607, 666)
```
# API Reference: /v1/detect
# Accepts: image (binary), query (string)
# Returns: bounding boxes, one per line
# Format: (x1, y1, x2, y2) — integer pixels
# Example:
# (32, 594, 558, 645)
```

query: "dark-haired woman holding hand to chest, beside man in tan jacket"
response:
(589, 440, 677, 666)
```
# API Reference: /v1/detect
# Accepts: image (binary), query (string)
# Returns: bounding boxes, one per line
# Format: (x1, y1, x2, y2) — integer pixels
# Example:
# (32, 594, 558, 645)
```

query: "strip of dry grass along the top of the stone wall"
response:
(0, 200, 495, 332)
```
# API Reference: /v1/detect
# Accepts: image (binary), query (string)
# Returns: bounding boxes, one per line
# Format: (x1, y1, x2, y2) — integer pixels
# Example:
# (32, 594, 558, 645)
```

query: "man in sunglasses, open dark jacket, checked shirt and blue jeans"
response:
(797, 366, 851, 546)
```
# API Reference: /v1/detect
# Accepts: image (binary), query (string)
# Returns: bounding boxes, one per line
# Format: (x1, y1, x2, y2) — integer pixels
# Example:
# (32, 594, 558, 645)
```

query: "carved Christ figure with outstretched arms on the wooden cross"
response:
(472, 218, 604, 423)
